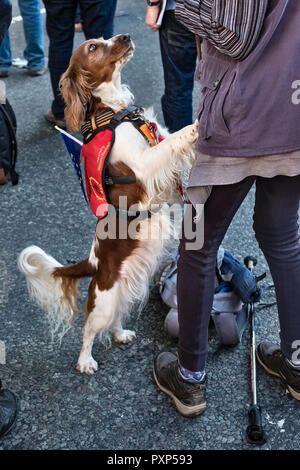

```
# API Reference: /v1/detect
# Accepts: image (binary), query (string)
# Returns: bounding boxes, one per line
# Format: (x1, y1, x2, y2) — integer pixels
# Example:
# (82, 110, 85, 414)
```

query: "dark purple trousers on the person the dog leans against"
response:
(178, 176, 300, 370)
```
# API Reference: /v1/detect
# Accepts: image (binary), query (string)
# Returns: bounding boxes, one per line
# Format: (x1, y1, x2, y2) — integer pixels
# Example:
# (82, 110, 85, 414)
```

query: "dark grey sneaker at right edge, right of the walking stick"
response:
(256, 342, 300, 401)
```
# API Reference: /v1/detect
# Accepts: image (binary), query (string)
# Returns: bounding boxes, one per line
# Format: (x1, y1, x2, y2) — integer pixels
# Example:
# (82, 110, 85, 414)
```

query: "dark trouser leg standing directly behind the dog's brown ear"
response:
(44, 0, 77, 119)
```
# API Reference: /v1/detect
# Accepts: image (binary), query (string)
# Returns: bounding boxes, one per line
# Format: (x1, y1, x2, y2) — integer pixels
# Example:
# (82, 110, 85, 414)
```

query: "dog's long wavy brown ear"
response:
(59, 66, 91, 132)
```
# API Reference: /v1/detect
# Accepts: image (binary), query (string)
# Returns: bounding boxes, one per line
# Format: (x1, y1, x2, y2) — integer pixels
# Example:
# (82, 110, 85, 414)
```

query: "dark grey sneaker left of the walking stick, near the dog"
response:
(153, 352, 206, 417)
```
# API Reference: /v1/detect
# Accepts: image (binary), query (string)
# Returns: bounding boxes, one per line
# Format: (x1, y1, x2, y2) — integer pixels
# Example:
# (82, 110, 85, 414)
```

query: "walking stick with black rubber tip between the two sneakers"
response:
(244, 256, 266, 446)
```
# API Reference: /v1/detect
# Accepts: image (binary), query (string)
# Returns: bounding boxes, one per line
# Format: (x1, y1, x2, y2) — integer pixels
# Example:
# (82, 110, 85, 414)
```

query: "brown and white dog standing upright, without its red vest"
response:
(18, 35, 198, 374)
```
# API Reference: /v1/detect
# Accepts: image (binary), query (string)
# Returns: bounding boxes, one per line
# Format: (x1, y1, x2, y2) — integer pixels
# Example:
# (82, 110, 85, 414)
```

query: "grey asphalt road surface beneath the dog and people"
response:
(0, 0, 300, 450)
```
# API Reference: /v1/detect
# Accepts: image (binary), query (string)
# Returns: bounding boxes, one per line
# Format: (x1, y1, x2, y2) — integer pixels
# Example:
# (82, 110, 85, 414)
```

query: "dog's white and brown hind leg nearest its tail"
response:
(76, 278, 120, 375)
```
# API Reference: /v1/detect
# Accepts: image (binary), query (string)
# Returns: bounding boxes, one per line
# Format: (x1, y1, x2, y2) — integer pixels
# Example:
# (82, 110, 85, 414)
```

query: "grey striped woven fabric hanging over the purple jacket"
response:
(175, 0, 269, 60)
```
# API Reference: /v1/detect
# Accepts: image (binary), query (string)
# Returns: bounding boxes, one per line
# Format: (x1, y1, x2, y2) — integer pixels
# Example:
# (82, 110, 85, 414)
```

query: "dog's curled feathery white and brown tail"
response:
(18, 246, 95, 339)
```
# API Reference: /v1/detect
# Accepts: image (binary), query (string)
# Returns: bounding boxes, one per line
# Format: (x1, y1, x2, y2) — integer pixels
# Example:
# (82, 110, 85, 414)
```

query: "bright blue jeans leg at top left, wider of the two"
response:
(19, 0, 45, 70)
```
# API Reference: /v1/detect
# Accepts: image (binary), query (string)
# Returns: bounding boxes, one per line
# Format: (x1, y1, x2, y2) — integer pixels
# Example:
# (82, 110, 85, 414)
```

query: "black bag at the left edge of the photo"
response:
(0, 100, 19, 185)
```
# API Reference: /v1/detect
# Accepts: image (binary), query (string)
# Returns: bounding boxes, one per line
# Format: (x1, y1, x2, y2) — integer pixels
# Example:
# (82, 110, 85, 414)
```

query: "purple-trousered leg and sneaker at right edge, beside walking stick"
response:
(254, 175, 300, 400)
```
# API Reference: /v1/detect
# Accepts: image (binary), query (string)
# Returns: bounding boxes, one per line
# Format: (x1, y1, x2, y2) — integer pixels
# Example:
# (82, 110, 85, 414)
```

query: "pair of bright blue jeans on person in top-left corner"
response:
(0, 0, 45, 70)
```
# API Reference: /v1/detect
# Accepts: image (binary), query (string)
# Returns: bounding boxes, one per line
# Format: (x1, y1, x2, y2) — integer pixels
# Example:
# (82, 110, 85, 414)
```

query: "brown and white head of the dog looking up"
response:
(59, 34, 134, 131)
